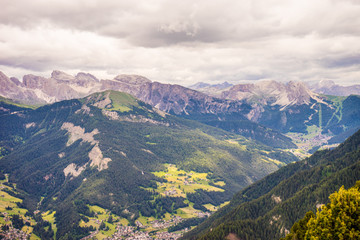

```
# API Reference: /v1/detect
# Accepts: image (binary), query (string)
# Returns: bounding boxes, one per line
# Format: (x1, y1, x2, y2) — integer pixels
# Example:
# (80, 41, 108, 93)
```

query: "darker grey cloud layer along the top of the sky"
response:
(0, 0, 360, 46)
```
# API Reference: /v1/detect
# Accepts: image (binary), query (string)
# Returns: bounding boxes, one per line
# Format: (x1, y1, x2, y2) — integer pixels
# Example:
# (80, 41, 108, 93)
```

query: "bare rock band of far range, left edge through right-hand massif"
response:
(0, 70, 321, 121)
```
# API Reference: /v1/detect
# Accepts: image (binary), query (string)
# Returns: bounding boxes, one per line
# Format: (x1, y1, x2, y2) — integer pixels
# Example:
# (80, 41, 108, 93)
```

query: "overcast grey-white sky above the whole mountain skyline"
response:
(0, 0, 360, 85)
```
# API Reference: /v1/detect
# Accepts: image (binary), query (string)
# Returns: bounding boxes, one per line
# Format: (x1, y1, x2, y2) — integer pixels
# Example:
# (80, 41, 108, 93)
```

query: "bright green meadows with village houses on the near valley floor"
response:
(0, 164, 226, 240)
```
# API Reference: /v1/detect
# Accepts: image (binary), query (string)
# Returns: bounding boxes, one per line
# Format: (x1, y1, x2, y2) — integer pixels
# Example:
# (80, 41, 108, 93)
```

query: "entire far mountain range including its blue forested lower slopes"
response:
(0, 71, 359, 152)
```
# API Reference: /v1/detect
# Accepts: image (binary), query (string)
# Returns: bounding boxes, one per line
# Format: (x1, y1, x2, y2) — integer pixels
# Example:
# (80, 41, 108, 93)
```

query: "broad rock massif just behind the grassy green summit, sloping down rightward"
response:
(101, 75, 248, 114)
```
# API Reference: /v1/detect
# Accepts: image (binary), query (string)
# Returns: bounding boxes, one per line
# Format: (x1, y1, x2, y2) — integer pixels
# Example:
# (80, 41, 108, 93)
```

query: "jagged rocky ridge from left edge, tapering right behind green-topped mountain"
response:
(0, 70, 250, 114)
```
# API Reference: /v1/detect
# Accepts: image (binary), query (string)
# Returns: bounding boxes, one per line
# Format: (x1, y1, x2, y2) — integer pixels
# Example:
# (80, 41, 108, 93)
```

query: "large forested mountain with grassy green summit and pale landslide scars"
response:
(0, 91, 297, 239)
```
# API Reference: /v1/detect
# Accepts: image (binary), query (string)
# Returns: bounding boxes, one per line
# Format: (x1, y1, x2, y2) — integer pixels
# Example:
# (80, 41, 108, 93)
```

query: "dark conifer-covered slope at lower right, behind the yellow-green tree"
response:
(183, 128, 360, 239)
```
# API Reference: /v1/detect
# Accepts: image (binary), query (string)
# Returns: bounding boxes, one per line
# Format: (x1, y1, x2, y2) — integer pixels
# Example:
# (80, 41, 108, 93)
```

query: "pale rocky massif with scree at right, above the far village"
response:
(221, 81, 324, 124)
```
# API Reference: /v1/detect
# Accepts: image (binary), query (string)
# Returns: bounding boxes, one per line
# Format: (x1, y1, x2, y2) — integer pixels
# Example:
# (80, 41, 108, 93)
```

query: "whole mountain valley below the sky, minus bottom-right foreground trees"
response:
(0, 71, 360, 239)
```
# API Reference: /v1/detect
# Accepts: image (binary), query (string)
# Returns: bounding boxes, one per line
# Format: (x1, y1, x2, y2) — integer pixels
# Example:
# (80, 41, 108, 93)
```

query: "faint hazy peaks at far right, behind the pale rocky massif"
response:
(308, 80, 360, 96)
